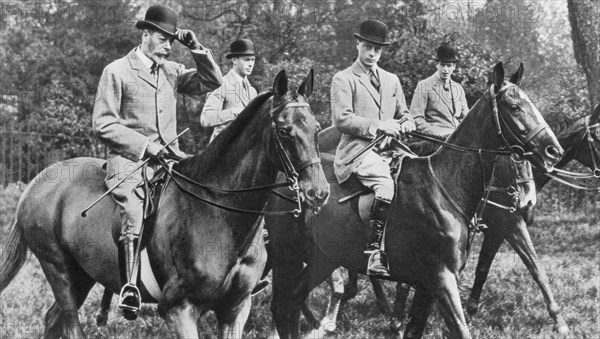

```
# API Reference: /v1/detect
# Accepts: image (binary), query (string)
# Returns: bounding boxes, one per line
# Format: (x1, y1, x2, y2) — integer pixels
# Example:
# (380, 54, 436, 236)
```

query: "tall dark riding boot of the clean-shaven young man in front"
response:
(365, 198, 390, 278)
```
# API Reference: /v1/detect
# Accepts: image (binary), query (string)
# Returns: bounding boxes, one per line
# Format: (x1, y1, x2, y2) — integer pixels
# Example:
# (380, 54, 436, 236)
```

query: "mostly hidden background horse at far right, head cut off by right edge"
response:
(330, 105, 600, 334)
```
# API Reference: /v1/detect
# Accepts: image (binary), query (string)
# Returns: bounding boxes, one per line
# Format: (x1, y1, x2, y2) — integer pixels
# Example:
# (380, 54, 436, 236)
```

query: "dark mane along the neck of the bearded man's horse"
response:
(174, 92, 273, 178)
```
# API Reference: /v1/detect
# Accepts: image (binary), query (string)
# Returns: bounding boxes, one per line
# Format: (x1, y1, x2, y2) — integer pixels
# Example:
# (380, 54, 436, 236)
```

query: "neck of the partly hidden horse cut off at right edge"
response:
(533, 119, 592, 192)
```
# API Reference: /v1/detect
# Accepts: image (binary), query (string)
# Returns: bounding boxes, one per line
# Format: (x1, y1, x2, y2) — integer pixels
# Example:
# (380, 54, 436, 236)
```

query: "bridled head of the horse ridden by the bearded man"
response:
(271, 69, 329, 211)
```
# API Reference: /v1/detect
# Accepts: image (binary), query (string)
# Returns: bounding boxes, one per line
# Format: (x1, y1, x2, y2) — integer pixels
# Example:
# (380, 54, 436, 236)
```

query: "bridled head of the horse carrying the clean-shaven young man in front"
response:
(489, 62, 564, 172)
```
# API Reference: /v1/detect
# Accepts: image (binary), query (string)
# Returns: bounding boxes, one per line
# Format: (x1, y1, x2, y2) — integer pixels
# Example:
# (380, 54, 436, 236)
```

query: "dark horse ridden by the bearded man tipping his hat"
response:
(0, 71, 329, 338)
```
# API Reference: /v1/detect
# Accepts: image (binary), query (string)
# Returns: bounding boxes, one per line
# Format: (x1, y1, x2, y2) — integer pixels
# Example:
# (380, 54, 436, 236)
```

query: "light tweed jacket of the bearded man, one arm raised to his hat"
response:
(92, 47, 222, 179)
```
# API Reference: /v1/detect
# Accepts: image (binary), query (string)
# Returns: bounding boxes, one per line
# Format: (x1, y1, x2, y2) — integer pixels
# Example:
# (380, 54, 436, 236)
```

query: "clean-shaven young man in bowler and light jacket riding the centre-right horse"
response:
(331, 20, 415, 277)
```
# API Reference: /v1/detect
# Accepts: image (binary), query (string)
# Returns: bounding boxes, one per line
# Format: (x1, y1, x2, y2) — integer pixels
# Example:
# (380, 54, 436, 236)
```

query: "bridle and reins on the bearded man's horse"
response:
(163, 98, 321, 217)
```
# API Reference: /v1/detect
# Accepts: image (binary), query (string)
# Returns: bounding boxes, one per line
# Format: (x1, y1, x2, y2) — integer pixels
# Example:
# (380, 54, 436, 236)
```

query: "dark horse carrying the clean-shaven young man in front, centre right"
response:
(266, 63, 562, 339)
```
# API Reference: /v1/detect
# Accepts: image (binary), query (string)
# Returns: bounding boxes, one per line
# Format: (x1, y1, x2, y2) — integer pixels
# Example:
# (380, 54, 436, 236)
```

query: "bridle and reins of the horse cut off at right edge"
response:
(544, 118, 600, 192)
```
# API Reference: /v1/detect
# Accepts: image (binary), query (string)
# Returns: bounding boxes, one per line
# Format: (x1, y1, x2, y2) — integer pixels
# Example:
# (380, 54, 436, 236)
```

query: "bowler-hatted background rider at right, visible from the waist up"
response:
(410, 45, 469, 140)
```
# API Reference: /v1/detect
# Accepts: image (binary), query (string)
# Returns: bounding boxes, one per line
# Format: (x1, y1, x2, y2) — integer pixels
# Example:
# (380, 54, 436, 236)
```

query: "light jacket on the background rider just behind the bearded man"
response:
(200, 69, 257, 141)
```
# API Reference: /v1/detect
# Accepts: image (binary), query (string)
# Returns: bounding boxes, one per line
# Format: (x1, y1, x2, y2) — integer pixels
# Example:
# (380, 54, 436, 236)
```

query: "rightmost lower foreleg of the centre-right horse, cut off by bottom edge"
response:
(428, 269, 471, 339)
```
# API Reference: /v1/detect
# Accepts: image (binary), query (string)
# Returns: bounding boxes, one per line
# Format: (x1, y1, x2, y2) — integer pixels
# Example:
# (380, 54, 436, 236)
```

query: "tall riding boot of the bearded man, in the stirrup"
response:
(118, 225, 141, 320)
